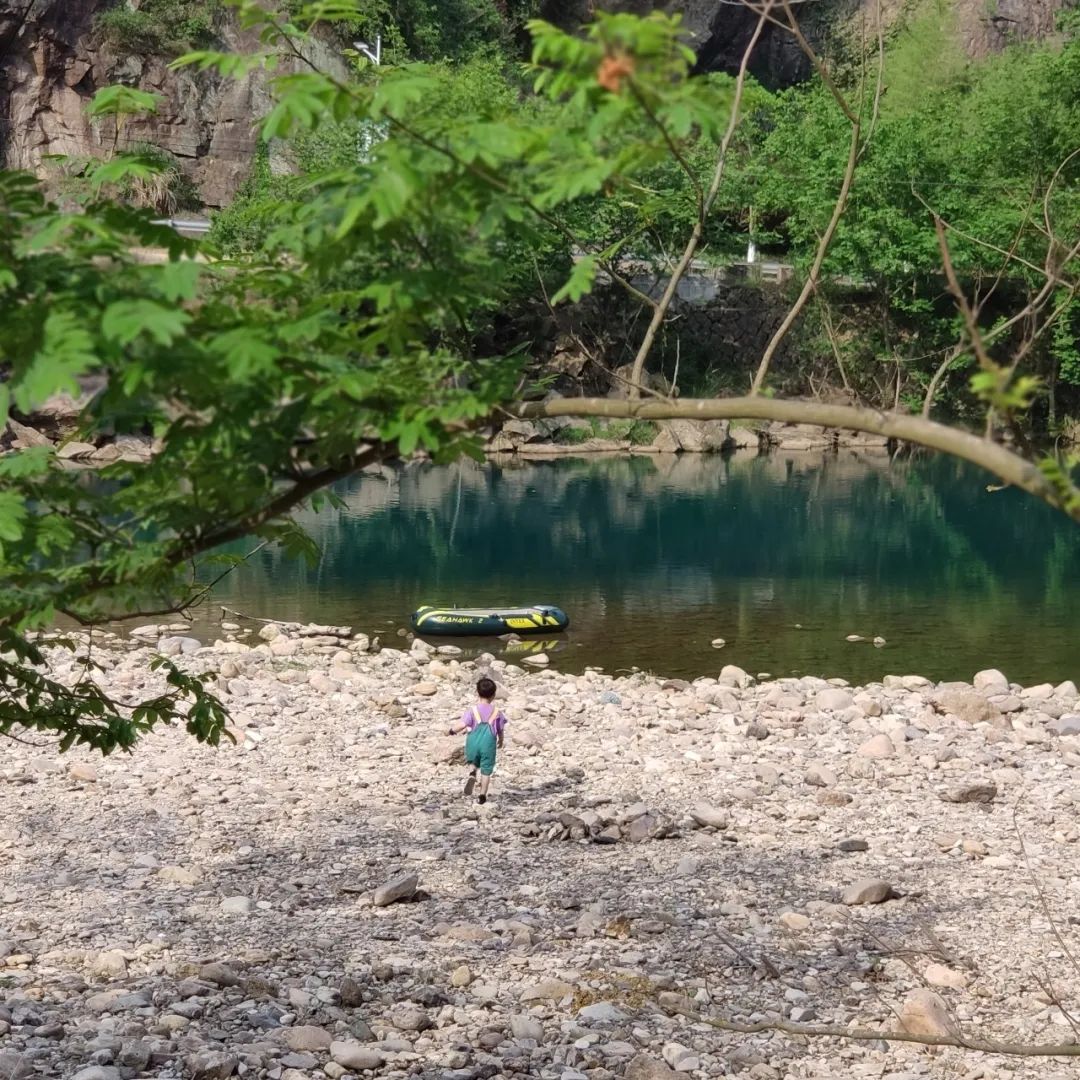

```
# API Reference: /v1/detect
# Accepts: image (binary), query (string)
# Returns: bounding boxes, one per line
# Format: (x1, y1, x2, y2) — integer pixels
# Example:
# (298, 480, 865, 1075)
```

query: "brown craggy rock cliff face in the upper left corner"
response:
(0, 0, 267, 206)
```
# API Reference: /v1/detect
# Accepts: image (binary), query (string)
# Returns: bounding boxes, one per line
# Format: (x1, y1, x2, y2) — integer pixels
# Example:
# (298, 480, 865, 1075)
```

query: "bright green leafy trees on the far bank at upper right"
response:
(743, 10, 1080, 416)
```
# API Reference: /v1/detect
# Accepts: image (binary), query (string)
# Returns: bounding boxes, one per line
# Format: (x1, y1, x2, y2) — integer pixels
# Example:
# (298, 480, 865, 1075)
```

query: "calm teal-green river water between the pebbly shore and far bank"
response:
(208, 453, 1080, 684)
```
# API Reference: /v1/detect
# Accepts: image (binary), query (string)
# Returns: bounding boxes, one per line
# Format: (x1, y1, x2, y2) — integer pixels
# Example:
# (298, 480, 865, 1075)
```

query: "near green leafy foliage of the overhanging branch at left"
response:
(10, 3, 699, 750)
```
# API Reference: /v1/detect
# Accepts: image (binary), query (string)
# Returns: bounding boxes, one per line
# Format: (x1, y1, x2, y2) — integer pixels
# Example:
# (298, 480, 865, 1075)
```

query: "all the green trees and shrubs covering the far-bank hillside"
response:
(208, 0, 1080, 433)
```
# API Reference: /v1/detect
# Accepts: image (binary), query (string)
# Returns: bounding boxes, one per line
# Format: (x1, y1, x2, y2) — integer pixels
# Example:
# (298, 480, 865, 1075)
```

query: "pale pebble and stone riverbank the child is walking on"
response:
(0, 624, 1080, 1080)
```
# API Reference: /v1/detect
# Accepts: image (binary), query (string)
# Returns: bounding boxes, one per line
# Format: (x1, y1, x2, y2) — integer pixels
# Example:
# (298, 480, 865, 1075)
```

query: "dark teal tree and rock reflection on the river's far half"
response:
(247, 454, 1080, 599)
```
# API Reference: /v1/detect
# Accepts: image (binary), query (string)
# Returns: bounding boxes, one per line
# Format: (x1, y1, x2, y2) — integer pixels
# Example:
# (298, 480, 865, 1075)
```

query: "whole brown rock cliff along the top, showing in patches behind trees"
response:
(0, 0, 1075, 206)
